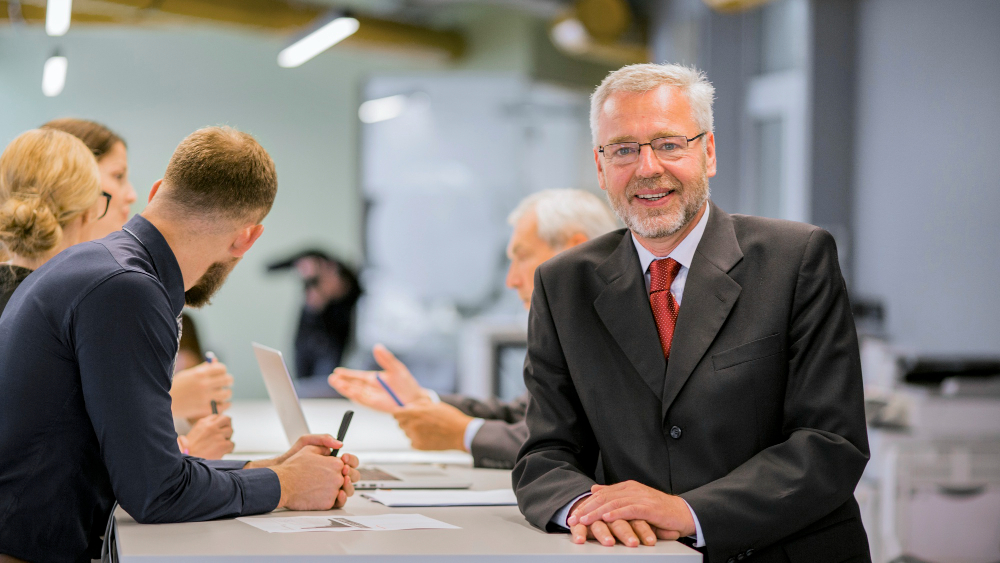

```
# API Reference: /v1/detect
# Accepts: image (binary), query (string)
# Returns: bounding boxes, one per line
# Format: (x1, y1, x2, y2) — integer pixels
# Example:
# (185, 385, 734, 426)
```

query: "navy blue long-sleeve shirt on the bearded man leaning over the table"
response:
(0, 216, 281, 561)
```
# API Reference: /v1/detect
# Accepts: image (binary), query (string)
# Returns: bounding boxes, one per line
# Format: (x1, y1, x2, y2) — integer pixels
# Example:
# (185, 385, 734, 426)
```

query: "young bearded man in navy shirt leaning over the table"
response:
(0, 127, 358, 562)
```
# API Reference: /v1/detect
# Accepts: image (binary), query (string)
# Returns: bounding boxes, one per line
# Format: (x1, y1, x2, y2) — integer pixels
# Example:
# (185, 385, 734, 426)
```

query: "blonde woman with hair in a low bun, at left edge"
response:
(0, 129, 105, 313)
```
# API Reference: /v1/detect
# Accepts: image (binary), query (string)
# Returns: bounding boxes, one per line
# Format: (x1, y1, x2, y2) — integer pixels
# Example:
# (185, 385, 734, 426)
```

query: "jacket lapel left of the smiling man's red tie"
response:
(594, 231, 667, 397)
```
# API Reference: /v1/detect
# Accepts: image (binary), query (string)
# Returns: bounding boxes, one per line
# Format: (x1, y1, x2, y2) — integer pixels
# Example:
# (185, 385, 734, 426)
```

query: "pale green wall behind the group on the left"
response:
(0, 26, 443, 397)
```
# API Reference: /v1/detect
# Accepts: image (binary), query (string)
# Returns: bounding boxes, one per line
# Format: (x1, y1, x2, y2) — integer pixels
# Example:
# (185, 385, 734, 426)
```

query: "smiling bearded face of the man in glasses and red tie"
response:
(594, 85, 715, 240)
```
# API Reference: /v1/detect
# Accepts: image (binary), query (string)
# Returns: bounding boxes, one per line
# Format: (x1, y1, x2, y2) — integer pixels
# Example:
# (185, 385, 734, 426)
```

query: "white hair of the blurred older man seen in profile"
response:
(507, 189, 619, 249)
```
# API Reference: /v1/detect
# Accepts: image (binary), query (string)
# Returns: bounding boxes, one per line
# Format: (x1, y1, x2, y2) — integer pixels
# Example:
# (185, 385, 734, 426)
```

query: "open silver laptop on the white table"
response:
(253, 342, 472, 490)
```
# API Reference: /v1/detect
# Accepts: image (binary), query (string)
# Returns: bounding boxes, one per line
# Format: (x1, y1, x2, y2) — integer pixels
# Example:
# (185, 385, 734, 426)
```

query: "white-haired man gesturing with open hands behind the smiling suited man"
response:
(329, 190, 618, 469)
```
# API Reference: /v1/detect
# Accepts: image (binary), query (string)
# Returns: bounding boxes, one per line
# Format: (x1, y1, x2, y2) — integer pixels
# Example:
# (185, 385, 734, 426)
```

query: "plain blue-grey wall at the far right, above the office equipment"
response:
(854, 0, 1000, 354)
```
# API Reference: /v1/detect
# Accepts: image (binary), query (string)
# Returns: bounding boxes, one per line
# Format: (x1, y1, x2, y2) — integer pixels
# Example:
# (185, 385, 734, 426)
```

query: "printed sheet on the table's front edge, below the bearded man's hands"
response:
(237, 514, 459, 534)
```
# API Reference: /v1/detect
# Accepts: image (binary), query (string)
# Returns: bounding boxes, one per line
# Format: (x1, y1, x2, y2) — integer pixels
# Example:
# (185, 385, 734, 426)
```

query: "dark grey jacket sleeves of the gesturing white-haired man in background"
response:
(441, 393, 528, 469)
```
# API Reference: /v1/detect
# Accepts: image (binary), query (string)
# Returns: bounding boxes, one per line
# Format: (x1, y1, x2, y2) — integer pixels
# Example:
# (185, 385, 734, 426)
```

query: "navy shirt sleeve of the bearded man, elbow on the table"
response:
(71, 273, 281, 523)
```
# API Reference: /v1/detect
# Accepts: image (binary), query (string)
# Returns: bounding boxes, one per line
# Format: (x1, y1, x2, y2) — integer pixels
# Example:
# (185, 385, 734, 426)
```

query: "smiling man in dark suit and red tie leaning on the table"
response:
(513, 65, 870, 563)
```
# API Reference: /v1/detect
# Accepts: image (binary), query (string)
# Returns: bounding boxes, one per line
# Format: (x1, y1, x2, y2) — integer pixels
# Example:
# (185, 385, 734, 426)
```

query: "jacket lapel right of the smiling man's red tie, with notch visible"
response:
(656, 202, 743, 417)
